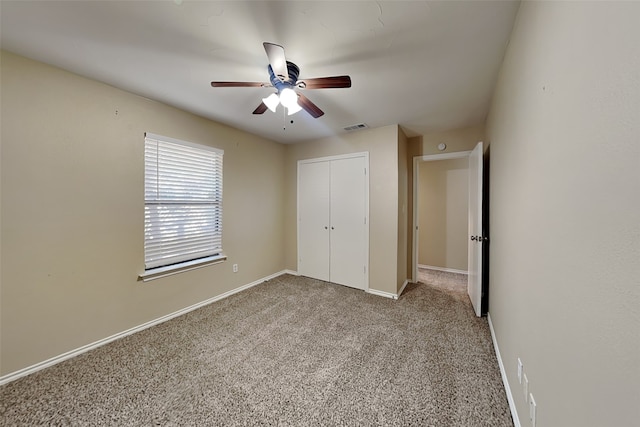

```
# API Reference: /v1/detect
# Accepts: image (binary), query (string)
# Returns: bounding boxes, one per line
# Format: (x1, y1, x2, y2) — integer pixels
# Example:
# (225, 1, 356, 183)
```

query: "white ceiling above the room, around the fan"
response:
(0, 0, 519, 143)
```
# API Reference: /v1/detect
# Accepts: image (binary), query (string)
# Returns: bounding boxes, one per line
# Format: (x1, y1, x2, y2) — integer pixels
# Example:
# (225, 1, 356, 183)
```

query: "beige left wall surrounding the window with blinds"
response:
(0, 53, 285, 374)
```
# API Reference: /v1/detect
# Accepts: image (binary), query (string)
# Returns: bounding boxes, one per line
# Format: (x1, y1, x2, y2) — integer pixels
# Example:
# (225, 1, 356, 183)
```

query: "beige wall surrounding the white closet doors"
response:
(285, 125, 399, 294)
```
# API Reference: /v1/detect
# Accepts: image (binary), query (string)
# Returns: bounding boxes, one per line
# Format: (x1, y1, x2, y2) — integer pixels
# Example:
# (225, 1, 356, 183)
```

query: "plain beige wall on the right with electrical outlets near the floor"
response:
(487, 1, 640, 427)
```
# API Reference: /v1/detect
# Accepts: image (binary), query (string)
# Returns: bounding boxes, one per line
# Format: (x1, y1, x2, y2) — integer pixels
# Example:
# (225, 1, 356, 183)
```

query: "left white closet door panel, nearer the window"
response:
(298, 162, 330, 281)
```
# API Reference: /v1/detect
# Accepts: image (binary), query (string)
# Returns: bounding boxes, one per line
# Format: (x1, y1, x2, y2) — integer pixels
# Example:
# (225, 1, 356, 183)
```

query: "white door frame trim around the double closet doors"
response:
(296, 151, 371, 292)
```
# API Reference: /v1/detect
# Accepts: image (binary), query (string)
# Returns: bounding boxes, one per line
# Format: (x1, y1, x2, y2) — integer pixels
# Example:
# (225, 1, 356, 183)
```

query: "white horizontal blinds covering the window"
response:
(144, 133, 224, 270)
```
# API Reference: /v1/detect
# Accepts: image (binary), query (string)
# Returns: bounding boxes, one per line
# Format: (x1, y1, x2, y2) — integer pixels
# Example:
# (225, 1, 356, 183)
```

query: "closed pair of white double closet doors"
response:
(298, 153, 369, 290)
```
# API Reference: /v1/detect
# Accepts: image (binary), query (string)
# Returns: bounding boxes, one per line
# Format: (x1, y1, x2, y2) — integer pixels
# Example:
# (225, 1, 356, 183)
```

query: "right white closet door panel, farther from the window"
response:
(329, 157, 367, 289)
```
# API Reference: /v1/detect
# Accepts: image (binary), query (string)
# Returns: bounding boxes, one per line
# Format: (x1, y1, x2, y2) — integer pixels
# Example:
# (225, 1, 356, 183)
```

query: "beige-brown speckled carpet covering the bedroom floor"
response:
(0, 275, 513, 427)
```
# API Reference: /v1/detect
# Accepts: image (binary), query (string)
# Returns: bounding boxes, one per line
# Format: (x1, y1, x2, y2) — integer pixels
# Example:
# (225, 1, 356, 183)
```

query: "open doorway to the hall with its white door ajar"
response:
(412, 142, 488, 316)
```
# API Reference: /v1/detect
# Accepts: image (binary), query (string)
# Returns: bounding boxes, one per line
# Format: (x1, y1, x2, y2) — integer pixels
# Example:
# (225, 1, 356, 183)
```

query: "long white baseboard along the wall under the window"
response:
(0, 270, 290, 385)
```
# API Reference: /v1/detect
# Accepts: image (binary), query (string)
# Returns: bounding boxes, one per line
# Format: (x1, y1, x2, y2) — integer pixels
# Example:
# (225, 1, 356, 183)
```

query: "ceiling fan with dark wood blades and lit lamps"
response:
(211, 42, 351, 119)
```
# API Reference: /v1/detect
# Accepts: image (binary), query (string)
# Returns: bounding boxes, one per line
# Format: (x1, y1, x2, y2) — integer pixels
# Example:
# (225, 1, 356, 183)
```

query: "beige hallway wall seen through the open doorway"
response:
(418, 158, 469, 271)
